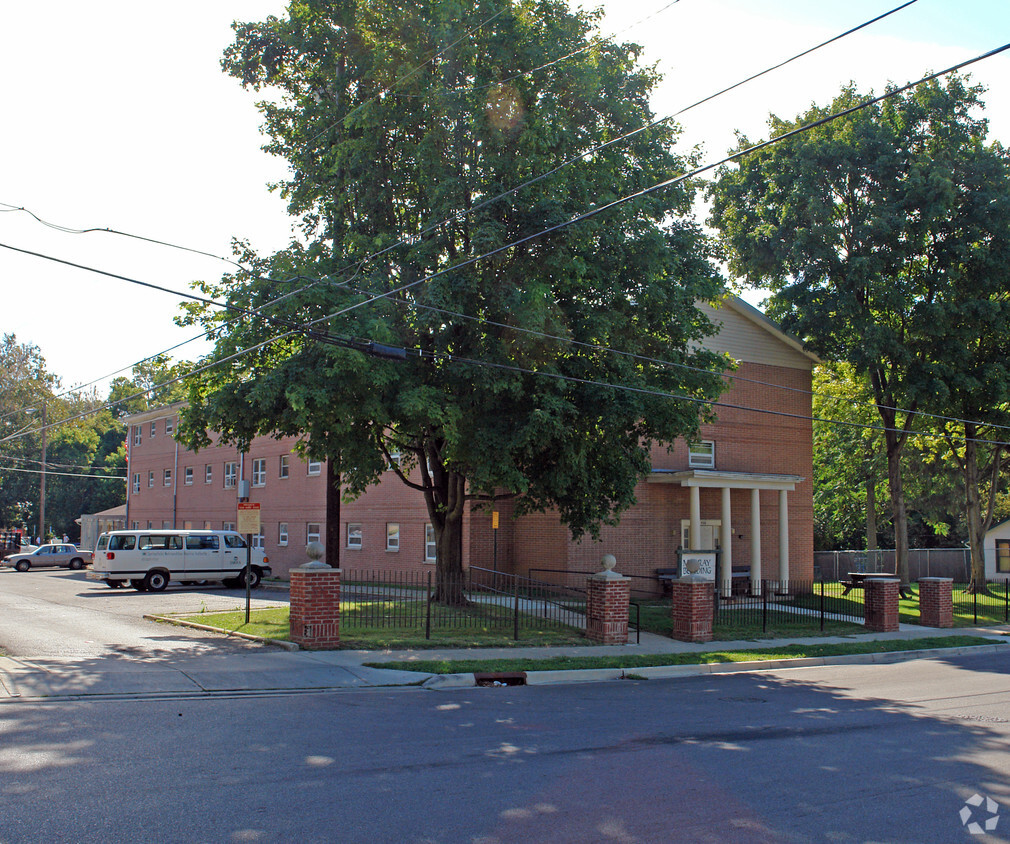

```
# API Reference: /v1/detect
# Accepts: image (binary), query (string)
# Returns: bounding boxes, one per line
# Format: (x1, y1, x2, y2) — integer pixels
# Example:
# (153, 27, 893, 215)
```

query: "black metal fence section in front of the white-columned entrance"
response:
(712, 579, 865, 636)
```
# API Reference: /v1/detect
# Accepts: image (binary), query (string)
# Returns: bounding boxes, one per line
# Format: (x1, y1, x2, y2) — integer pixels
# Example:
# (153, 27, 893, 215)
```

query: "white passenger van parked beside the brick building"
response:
(88, 530, 271, 592)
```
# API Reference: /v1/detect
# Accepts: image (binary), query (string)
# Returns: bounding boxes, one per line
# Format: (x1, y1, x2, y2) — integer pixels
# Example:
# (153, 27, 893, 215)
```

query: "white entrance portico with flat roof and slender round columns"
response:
(648, 469, 804, 597)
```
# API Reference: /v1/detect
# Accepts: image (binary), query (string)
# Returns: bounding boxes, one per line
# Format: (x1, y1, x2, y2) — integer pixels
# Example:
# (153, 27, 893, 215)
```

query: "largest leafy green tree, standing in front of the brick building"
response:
(175, 0, 725, 601)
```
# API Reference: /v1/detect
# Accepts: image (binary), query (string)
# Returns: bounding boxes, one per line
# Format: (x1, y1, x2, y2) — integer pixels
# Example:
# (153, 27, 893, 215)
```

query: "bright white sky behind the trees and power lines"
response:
(0, 0, 1010, 393)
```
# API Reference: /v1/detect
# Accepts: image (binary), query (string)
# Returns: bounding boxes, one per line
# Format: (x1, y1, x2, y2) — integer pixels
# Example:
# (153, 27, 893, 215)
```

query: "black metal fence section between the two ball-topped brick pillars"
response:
(340, 566, 586, 639)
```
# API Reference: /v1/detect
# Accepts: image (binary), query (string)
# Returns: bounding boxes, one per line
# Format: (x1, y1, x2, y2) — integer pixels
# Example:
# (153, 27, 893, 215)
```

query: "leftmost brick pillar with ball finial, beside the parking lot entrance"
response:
(289, 542, 340, 650)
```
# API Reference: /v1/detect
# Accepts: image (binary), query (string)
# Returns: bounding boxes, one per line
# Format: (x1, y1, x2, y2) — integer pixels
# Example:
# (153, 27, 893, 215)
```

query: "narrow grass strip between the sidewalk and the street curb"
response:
(365, 636, 993, 674)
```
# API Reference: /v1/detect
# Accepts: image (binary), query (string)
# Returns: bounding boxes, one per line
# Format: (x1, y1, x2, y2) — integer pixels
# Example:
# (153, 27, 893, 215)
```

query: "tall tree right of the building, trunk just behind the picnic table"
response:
(712, 77, 1008, 582)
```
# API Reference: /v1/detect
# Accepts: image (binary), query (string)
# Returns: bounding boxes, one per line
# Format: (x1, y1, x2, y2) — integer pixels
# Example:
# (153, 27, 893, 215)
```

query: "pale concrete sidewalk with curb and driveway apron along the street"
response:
(0, 625, 1010, 704)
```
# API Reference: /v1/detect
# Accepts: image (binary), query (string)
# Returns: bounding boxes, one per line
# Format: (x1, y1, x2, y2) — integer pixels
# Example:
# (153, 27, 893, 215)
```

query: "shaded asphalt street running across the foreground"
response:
(0, 654, 1010, 844)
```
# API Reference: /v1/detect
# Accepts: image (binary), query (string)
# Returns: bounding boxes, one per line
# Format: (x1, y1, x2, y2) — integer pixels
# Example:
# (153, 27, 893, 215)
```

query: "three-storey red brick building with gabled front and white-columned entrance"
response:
(126, 298, 816, 581)
